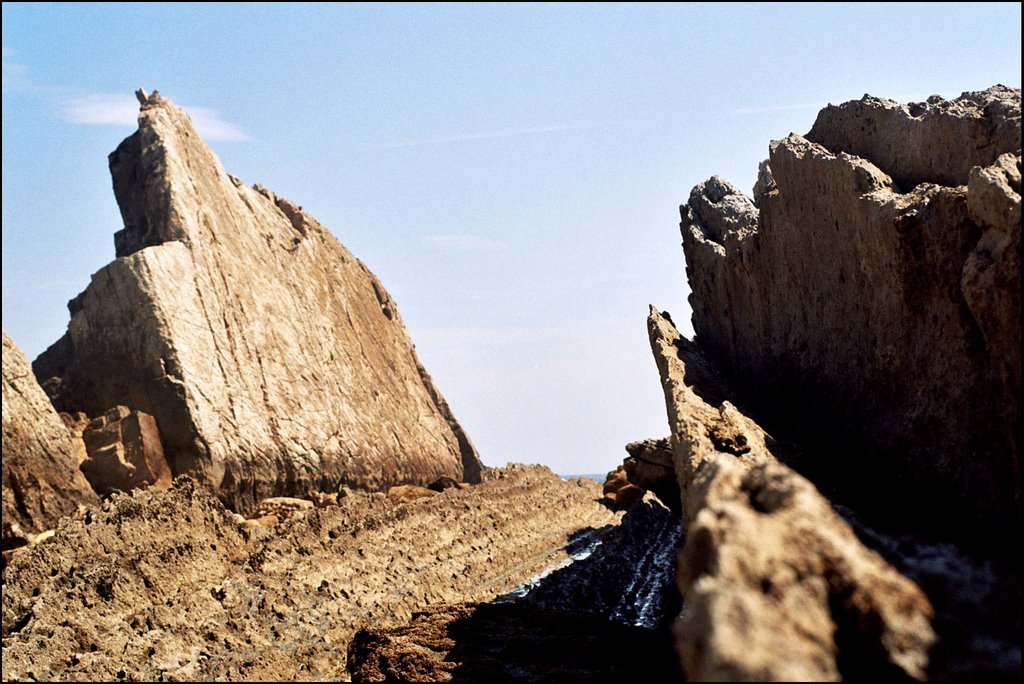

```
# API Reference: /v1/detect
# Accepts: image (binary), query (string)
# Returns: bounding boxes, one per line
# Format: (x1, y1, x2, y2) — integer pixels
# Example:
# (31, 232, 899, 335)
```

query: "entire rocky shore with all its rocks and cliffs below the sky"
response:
(2, 86, 1022, 682)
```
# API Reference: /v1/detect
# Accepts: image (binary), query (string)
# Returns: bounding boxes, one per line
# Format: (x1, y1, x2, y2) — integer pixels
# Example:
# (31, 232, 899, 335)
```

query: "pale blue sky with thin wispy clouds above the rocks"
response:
(2, 2, 1021, 473)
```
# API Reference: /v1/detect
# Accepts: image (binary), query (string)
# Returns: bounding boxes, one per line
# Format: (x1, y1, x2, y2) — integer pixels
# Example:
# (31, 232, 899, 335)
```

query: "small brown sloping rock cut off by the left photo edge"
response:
(2, 331, 98, 550)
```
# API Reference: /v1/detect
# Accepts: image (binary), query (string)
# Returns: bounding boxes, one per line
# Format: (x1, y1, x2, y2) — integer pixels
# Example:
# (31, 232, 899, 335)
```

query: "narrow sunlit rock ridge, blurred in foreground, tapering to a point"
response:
(648, 308, 935, 681)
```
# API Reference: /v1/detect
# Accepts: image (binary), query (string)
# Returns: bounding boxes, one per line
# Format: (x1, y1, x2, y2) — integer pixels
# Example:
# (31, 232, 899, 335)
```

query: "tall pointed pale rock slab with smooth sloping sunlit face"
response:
(34, 93, 480, 509)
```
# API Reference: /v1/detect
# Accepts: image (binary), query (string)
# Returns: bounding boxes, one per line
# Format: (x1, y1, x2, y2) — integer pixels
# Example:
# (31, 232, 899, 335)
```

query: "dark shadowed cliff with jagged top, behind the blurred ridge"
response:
(681, 86, 1021, 555)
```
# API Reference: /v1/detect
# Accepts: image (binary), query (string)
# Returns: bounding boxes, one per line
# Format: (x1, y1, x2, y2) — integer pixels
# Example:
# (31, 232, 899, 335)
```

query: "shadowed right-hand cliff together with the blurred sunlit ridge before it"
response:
(648, 86, 1021, 681)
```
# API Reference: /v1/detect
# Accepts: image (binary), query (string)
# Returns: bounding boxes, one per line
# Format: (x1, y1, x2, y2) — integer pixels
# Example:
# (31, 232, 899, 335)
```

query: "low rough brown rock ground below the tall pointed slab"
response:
(2, 466, 622, 681)
